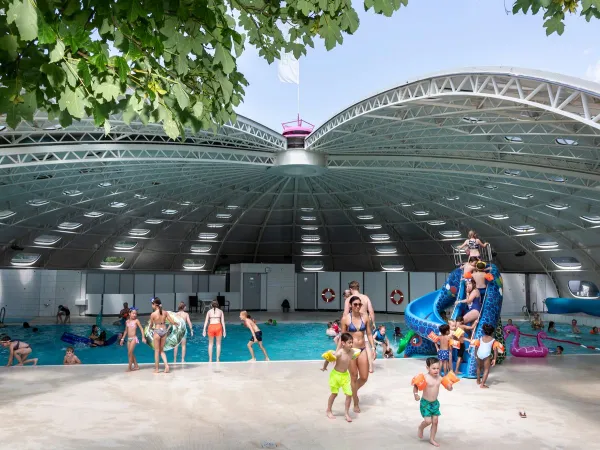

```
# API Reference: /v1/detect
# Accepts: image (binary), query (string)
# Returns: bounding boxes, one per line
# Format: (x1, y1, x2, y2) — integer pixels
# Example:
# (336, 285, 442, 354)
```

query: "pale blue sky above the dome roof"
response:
(237, 0, 600, 132)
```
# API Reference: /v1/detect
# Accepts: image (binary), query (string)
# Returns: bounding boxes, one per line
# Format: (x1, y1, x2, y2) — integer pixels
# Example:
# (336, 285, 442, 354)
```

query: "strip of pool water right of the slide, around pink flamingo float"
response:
(506, 322, 600, 356)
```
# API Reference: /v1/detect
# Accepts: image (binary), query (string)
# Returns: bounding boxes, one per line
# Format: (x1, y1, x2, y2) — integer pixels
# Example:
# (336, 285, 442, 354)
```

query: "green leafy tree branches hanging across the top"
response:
(0, 0, 600, 139)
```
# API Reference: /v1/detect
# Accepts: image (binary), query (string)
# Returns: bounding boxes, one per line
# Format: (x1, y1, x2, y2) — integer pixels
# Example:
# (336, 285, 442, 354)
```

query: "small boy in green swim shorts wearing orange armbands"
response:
(413, 357, 452, 447)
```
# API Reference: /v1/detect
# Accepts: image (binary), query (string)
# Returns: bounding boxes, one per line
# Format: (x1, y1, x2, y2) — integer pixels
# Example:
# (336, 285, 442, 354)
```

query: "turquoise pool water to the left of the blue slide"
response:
(0, 323, 404, 365)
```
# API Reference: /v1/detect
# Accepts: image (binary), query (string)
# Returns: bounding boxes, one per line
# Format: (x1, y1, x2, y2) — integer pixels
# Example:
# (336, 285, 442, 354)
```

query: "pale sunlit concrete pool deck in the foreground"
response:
(0, 355, 600, 450)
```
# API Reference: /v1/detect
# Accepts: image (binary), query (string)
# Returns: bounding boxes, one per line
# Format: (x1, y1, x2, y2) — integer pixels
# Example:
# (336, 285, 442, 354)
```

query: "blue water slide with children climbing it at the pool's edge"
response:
(404, 264, 502, 378)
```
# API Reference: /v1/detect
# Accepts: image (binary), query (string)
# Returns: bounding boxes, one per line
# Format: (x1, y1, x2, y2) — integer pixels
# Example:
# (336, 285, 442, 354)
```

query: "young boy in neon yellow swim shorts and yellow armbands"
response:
(321, 333, 354, 422)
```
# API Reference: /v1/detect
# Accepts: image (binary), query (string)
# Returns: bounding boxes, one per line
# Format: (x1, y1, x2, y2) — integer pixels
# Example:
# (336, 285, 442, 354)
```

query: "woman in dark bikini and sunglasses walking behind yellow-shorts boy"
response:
(338, 295, 375, 413)
